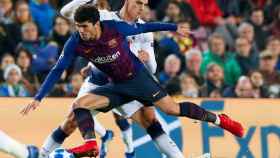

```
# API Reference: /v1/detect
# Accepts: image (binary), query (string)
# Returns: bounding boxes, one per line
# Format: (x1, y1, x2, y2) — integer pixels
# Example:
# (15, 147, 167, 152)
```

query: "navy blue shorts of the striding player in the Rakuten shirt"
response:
(91, 68, 167, 112)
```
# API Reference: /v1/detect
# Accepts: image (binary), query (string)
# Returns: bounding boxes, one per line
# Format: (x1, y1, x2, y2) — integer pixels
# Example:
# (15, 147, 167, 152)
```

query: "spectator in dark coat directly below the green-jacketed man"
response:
(200, 63, 227, 97)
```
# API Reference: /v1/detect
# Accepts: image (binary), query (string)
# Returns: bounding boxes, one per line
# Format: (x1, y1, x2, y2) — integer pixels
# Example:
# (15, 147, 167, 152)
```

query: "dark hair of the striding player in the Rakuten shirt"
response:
(74, 4, 99, 25)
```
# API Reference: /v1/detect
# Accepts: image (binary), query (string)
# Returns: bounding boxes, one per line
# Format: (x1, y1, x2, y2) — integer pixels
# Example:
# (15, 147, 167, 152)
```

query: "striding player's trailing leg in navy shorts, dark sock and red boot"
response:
(130, 69, 244, 137)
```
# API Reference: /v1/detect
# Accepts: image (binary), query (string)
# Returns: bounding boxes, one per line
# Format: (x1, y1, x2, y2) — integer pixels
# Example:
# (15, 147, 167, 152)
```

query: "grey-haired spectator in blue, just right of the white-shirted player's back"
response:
(158, 54, 181, 85)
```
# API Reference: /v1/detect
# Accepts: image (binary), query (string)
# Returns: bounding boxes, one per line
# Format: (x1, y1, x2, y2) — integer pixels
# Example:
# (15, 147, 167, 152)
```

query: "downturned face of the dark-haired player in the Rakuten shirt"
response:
(75, 21, 99, 41)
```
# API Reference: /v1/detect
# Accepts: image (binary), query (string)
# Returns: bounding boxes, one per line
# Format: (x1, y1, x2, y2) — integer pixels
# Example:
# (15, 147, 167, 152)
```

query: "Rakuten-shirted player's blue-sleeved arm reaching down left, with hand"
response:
(20, 36, 77, 115)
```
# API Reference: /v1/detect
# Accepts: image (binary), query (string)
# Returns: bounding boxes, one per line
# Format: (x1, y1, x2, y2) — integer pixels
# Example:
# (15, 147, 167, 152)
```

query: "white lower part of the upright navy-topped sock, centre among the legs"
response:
(121, 127, 134, 153)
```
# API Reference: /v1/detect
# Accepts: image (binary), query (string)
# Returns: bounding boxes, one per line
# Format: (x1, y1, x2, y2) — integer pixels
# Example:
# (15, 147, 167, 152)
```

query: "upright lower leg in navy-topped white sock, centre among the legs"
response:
(113, 112, 135, 158)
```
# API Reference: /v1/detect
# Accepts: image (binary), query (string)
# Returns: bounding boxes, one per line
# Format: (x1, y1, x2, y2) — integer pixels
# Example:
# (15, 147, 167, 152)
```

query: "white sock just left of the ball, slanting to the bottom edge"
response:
(39, 134, 61, 158)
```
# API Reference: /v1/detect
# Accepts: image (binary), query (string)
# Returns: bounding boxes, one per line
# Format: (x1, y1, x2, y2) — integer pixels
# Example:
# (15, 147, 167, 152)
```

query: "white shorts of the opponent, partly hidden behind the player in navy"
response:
(78, 78, 143, 118)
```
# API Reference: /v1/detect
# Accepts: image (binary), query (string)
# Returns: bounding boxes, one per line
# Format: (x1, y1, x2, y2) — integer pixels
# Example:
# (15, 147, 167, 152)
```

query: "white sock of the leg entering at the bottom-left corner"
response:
(0, 131, 28, 158)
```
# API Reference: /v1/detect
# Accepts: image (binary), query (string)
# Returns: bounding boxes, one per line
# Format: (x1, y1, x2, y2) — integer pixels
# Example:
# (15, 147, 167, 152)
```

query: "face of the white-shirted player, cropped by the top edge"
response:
(126, 0, 148, 20)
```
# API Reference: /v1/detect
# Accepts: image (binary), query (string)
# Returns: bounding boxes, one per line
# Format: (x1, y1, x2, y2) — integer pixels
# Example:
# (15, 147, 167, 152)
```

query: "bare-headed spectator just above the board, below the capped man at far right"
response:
(249, 70, 269, 98)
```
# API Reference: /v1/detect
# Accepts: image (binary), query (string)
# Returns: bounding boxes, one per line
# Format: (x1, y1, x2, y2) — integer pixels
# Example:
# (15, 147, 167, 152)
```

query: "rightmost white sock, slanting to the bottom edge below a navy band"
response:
(154, 134, 184, 158)
